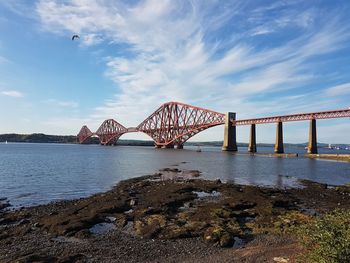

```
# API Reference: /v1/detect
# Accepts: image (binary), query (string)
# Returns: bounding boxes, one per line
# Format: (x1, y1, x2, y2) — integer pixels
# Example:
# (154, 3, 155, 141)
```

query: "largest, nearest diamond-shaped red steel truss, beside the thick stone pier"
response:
(137, 102, 225, 147)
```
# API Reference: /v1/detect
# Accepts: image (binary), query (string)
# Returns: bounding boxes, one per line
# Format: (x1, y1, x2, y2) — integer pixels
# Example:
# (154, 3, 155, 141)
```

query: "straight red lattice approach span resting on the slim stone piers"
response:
(235, 109, 350, 126)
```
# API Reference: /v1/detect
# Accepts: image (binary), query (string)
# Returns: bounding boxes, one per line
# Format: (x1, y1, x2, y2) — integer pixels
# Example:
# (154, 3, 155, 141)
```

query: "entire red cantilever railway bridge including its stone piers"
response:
(77, 102, 350, 153)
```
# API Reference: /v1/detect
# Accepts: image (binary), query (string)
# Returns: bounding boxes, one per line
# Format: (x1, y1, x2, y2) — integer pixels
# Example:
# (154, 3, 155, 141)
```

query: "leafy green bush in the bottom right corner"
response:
(297, 209, 350, 263)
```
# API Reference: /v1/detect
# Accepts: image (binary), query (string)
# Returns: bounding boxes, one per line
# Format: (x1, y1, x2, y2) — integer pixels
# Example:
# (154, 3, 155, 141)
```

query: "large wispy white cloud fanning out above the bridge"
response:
(36, 0, 350, 142)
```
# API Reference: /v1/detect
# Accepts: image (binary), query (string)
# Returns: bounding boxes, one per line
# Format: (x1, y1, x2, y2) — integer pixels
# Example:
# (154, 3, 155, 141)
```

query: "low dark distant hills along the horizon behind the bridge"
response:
(0, 133, 350, 148)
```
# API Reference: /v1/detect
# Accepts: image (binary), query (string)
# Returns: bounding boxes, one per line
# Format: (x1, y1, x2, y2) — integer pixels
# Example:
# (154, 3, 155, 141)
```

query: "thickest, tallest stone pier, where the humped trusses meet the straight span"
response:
(222, 112, 237, 152)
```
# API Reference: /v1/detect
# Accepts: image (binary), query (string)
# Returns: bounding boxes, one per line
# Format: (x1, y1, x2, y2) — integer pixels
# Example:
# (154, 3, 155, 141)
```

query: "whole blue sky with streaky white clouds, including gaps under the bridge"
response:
(0, 0, 350, 143)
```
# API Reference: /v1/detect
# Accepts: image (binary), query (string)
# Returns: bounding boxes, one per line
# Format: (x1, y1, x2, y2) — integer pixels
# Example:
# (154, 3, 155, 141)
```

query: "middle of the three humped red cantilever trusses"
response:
(96, 119, 128, 145)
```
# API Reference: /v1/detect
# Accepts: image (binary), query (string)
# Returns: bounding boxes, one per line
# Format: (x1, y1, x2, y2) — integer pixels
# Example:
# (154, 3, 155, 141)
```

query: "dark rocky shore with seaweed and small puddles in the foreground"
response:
(0, 168, 350, 262)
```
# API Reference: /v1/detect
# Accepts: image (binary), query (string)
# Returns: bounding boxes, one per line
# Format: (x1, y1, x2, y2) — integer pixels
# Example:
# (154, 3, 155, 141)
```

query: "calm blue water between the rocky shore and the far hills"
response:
(0, 143, 350, 207)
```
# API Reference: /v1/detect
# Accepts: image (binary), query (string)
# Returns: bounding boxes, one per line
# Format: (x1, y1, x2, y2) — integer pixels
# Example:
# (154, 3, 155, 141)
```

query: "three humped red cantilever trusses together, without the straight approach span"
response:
(78, 102, 225, 148)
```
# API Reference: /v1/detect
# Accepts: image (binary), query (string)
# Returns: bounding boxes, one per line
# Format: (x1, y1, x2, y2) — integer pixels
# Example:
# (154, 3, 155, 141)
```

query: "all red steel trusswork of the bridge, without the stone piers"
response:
(77, 102, 350, 148)
